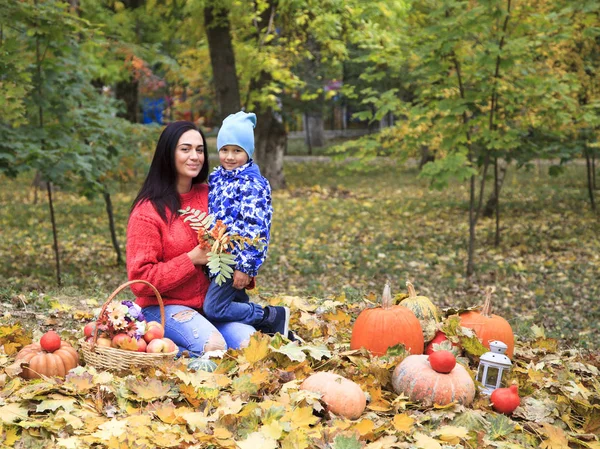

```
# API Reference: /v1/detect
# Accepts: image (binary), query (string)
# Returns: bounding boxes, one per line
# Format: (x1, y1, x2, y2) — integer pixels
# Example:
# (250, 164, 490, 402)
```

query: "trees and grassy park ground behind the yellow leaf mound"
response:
(0, 0, 599, 347)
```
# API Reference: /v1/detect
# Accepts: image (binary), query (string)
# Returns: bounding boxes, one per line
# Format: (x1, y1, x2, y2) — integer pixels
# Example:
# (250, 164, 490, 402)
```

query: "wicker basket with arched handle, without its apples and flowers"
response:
(81, 280, 178, 371)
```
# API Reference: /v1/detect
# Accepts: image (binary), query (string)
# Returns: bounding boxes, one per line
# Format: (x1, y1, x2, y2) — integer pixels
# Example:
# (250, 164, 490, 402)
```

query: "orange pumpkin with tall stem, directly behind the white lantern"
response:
(460, 289, 515, 359)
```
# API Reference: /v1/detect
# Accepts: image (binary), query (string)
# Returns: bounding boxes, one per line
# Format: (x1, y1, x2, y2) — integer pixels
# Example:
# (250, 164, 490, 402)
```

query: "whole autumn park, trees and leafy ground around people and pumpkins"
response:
(0, 0, 600, 449)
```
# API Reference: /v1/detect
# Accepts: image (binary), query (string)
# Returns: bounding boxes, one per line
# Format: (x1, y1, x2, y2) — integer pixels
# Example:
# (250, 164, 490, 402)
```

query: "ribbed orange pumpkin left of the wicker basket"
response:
(16, 341, 79, 379)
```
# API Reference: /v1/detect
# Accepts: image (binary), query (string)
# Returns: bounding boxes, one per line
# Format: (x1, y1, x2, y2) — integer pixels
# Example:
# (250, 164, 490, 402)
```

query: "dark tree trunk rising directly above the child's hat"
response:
(204, 2, 241, 125)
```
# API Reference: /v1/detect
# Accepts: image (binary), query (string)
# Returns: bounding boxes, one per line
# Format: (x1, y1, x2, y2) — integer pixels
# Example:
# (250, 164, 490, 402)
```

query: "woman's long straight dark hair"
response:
(131, 121, 208, 222)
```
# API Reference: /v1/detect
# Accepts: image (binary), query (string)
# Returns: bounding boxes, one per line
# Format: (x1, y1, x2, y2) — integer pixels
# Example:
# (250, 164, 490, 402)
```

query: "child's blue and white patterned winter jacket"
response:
(208, 160, 273, 276)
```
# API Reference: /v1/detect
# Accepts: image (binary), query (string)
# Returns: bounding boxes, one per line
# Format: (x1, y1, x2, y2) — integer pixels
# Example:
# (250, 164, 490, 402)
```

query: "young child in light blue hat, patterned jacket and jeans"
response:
(203, 111, 290, 337)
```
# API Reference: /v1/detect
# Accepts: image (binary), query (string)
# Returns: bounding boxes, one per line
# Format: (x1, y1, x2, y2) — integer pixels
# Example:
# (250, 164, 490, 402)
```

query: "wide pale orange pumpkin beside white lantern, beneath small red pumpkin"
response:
(392, 355, 475, 407)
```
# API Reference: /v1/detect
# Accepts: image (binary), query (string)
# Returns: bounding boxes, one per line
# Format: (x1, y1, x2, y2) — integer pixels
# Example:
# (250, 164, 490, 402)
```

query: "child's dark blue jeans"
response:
(202, 279, 265, 326)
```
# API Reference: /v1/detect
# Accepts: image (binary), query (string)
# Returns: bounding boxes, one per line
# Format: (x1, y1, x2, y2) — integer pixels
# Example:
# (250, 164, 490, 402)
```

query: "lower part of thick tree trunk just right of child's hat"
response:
(255, 108, 287, 190)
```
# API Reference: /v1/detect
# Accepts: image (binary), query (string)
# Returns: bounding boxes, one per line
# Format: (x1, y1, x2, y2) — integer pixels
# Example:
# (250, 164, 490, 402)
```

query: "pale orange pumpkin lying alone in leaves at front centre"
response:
(300, 372, 367, 419)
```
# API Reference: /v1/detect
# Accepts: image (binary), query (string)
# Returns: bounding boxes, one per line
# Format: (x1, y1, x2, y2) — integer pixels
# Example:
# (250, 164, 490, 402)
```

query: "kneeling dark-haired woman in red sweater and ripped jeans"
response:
(127, 121, 255, 356)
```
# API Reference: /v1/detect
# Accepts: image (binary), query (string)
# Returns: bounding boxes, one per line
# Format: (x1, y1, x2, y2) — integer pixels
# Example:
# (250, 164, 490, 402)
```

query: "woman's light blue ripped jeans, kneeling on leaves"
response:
(142, 305, 256, 356)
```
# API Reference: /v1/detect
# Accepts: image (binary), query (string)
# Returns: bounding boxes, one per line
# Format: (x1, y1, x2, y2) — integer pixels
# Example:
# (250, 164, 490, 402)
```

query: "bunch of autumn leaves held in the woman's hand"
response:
(179, 206, 263, 285)
